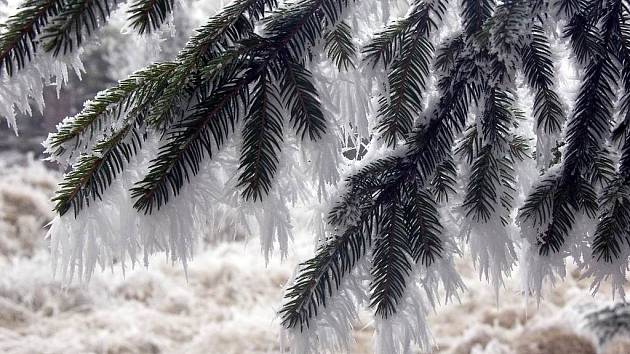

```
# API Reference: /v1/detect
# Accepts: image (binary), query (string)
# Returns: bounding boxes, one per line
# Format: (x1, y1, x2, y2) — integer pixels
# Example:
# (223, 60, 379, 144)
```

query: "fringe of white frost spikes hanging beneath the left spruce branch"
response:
(49, 105, 339, 282)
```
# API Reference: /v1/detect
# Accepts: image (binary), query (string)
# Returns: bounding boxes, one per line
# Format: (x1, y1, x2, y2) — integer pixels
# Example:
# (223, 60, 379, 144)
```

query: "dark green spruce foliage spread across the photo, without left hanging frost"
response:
(0, 0, 630, 350)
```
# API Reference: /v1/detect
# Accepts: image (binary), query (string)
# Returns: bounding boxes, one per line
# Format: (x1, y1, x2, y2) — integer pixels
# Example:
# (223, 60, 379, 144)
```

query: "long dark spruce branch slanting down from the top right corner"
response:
(521, 1, 622, 255)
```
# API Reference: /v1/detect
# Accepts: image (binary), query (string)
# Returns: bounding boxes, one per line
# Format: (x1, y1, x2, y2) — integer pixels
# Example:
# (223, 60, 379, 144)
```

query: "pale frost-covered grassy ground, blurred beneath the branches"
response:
(0, 155, 630, 354)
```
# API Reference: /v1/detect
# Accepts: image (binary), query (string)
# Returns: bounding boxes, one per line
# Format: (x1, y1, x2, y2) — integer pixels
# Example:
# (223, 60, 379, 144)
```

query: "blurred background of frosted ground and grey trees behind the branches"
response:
(0, 0, 630, 354)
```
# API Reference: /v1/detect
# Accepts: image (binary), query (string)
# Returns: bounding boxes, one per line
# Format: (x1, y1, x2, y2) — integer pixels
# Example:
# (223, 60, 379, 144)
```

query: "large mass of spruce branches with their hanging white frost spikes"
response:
(0, 0, 630, 353)
